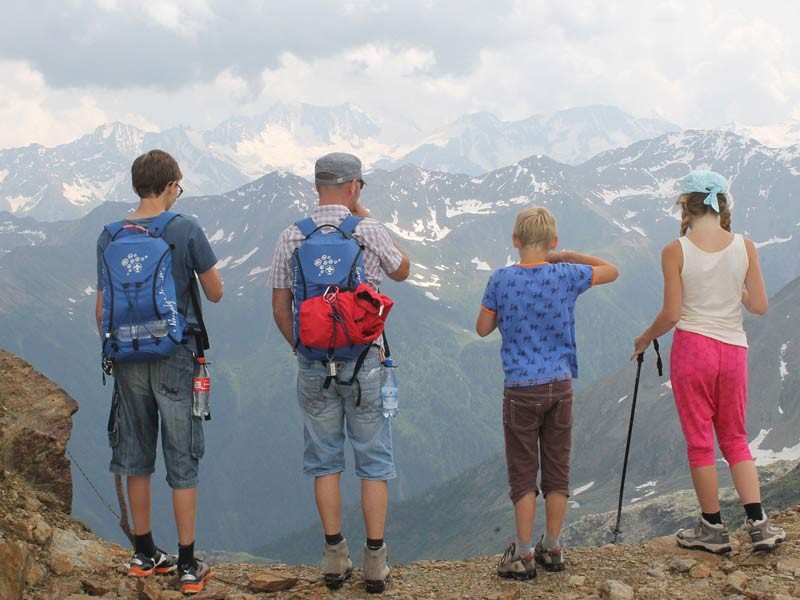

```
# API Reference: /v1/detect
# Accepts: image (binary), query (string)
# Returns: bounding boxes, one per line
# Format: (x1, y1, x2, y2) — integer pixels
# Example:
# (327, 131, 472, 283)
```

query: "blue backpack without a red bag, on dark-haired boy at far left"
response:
(101, 212, 186, 362)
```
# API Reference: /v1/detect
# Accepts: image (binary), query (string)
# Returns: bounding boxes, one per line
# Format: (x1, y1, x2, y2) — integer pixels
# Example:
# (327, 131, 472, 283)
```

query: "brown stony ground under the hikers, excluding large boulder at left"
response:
(0, 460, 800, 600)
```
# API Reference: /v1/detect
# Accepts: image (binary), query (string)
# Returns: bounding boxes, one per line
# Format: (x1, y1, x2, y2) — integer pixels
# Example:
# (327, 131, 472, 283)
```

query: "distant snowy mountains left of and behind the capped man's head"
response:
(0, 104, 388, 221)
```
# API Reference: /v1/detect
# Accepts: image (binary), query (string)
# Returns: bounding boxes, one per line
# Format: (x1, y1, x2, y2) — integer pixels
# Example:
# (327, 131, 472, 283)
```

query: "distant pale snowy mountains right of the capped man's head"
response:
(379, 106, 680, 175)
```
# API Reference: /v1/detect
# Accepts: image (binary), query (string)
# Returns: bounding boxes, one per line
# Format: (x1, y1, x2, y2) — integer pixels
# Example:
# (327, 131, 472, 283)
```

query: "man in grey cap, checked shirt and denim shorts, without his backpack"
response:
(269, 152, 410, 592)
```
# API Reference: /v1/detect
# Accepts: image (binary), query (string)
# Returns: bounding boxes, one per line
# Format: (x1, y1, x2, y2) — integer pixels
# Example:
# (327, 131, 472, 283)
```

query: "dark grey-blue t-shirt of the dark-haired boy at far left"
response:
(97, 215, 217, 345)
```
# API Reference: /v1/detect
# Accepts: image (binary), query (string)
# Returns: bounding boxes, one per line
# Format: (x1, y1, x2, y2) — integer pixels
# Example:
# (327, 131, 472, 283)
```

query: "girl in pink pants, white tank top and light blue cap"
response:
(631, 171, 786, 553)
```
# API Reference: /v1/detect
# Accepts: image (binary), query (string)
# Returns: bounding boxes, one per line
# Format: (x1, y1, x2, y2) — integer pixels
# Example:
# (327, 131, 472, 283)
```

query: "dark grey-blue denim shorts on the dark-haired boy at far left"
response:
(108, 346, 205, 489)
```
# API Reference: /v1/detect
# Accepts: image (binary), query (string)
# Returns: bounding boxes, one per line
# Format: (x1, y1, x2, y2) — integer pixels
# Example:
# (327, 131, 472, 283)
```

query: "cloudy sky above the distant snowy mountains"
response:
(0, 0, 800, 147)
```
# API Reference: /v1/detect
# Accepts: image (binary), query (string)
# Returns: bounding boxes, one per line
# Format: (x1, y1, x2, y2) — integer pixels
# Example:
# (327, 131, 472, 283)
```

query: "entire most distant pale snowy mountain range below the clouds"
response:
(0, 103, 676, 221)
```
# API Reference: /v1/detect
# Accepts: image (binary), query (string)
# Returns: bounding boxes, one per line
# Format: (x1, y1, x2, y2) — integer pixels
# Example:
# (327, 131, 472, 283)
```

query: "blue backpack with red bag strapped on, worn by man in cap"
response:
(292, 215, 371, 363)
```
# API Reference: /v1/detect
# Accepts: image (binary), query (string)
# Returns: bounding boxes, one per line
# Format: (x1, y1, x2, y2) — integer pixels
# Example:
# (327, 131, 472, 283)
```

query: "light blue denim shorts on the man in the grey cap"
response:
(297, 348, 396, 481)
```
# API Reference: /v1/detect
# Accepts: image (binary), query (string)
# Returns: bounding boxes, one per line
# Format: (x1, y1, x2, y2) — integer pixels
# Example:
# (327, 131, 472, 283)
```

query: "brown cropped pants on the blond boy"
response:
(503, 379, 572, 504)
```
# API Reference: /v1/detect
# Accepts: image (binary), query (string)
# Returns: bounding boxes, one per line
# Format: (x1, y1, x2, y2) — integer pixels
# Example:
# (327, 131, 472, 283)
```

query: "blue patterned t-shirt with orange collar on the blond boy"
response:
(481, 263, 594, 387)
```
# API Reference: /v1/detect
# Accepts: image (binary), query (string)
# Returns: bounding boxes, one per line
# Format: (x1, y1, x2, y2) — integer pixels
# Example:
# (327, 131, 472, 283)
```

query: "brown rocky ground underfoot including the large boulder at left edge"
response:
(0, 350, 800, 600)
